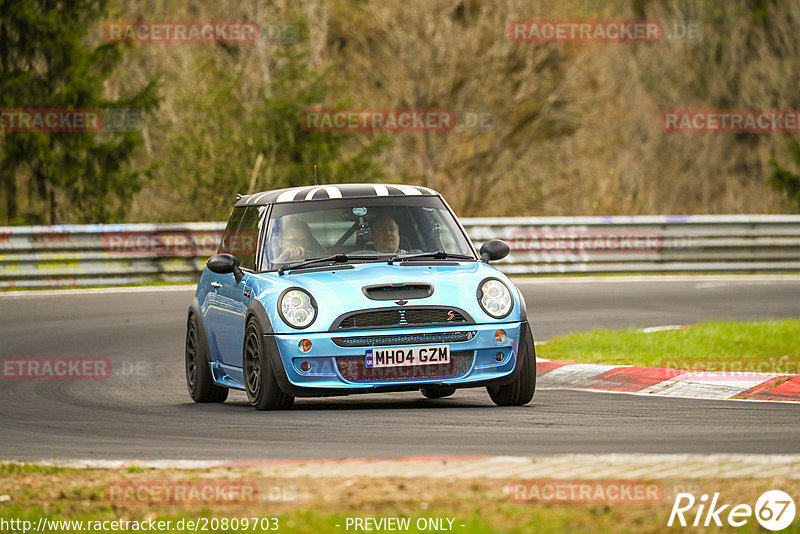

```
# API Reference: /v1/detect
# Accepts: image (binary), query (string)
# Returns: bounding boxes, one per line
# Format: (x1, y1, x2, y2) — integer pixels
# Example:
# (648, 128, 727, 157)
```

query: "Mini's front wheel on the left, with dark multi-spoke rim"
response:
(242, 318, 294, 410)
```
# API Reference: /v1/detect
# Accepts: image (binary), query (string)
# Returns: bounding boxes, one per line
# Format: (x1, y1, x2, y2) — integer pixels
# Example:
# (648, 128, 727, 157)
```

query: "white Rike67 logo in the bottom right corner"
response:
(667, 490, 795, 531)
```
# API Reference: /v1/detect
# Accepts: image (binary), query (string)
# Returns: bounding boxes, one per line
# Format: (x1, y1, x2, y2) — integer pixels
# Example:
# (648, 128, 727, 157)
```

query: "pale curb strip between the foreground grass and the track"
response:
(15, 454, 800, 480)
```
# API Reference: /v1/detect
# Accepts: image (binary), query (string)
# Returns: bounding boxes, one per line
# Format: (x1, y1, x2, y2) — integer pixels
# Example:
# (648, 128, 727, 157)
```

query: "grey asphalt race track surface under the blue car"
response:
(0, 276, 800, 459)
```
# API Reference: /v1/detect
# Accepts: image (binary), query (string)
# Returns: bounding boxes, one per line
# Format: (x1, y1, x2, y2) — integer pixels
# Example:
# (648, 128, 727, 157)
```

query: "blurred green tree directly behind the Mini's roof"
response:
(152, 39, 388, 220)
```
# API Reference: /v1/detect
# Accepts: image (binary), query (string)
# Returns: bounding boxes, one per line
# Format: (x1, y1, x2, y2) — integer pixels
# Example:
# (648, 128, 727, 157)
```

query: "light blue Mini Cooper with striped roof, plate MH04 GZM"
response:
(186, 184, 536, 410)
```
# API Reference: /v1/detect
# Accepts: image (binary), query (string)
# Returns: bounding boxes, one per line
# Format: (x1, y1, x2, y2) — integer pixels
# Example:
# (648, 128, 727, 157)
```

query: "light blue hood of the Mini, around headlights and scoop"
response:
(253, 261, 522, 333)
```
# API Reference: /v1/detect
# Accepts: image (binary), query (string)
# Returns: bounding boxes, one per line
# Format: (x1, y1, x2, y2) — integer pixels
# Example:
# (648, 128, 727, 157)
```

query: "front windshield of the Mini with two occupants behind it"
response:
(265, 197, 475, 270)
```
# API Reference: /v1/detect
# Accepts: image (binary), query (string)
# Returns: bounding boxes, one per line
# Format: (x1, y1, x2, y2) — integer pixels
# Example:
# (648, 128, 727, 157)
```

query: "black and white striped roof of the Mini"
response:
(236, 184, 439, 206)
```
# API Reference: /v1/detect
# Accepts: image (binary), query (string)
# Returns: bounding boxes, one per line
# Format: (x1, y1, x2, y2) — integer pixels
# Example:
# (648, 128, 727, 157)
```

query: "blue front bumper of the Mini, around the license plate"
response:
(264, 322, 528, 397)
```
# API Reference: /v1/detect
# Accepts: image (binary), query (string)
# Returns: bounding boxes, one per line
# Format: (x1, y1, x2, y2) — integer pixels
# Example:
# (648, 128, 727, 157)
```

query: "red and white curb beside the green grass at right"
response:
(537, 358, 800, 402)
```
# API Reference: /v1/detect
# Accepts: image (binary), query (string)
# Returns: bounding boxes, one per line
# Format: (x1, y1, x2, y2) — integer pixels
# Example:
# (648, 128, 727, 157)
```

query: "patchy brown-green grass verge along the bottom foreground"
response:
(0, 466, 800, 534)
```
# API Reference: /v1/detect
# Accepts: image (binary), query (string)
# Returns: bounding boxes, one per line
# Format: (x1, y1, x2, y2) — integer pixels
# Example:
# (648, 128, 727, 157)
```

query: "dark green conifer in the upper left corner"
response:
(0, 0, 158, 224)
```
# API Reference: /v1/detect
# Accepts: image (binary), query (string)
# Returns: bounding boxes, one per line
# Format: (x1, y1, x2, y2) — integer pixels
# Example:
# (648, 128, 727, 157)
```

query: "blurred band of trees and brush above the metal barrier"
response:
(0, 0, 800, 224)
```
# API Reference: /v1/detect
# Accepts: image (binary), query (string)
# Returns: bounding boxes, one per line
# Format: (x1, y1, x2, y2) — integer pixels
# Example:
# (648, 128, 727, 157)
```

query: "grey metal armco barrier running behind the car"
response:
(0, 215, 800, 288)
